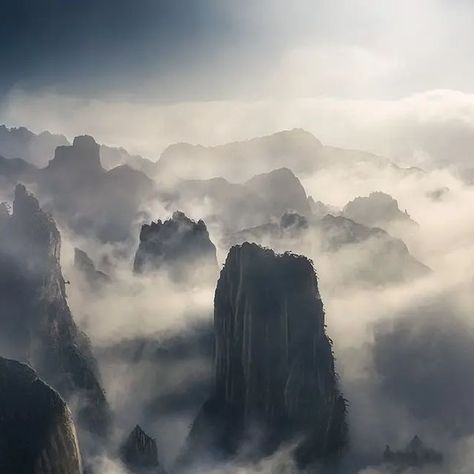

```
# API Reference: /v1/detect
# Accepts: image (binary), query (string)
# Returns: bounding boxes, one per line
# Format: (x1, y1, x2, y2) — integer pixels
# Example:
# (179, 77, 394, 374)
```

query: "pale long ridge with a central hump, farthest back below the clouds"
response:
(156, 129, 410, 182)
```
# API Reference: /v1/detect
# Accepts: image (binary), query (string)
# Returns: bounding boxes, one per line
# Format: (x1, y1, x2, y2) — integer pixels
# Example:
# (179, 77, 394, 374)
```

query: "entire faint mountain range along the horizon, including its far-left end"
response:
(0, 125, 420, 182)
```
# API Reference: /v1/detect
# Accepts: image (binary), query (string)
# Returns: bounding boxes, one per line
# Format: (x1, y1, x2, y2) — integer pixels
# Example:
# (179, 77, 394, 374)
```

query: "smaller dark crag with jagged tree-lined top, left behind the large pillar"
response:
(133, 211, 217, 281)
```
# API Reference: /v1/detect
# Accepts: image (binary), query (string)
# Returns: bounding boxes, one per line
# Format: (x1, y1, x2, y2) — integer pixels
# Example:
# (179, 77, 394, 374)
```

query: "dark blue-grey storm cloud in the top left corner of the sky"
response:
(0, 0, 248, 98)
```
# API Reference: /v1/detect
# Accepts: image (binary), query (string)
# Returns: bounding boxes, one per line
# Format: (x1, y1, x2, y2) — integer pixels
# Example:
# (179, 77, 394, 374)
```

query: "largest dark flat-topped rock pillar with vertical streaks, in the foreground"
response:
(183, 243, 346, 465)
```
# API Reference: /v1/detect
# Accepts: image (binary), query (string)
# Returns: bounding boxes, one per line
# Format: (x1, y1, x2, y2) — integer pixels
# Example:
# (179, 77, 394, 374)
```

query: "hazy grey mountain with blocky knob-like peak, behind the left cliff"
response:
(37, 136, 154, 242)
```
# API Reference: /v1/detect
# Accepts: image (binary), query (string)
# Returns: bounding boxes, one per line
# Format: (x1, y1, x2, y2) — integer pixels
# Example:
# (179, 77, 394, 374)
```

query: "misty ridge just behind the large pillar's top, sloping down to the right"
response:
(228, 212, 429, 284)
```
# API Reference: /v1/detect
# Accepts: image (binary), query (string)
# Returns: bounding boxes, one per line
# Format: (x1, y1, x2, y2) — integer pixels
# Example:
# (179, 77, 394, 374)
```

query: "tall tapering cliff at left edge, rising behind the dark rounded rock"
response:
(0, 185, 109, 435)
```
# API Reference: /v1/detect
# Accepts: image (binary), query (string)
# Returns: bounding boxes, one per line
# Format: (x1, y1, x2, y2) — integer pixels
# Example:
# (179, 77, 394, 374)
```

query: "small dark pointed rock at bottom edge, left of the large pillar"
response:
(120, 425, 164, 474)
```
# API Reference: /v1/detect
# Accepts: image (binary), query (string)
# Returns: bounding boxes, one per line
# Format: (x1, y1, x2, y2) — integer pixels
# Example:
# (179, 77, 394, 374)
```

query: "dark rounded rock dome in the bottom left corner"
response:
(0, 358, 82, 474)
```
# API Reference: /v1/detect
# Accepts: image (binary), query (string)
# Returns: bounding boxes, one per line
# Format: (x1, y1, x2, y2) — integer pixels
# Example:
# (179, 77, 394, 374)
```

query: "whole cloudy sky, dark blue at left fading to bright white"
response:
(0, 0, 474, 154)
